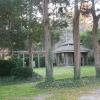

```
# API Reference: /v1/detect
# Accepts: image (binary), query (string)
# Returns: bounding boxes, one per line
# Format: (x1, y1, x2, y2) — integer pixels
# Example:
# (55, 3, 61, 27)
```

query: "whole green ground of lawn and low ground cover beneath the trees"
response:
(0, 67, 100, 100)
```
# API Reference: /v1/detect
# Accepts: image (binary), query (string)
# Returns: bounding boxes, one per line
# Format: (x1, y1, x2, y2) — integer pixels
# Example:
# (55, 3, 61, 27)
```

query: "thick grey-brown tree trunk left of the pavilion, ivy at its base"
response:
(43, 0, 53, 81)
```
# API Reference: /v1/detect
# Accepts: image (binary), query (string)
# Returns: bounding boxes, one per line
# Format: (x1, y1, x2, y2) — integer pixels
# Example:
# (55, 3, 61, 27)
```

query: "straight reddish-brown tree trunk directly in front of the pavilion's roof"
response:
(73, 0, 80, 79)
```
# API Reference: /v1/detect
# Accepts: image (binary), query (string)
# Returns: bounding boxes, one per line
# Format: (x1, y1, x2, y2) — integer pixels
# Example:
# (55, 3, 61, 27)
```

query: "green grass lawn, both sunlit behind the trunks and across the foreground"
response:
(0, 67, 100, 100)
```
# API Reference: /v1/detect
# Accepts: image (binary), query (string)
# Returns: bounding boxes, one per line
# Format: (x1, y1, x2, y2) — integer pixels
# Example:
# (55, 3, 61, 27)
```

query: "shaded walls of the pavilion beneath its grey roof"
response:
(56, 52, 87, 66)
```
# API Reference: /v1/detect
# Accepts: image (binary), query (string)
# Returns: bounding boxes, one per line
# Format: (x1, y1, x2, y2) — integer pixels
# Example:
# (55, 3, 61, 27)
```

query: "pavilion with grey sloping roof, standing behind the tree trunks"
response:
(54, 43, 89, 66)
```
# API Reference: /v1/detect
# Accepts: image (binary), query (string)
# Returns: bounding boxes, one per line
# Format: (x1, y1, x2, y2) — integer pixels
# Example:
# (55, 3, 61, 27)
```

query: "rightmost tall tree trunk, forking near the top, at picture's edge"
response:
(92, 0, 100, 77)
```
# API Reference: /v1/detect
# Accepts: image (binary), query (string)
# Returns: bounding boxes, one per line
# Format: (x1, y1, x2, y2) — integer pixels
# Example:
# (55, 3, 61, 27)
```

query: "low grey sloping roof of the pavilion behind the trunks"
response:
(53, 43, 90, 53)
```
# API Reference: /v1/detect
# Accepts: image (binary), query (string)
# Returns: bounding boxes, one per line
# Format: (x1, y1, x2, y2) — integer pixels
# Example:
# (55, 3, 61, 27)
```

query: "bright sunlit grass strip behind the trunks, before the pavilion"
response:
(34, 66, 95, 79)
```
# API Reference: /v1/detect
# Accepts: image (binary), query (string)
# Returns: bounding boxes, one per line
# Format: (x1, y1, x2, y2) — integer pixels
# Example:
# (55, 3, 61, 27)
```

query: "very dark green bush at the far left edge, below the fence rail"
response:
(0, 60, 16, 76)
